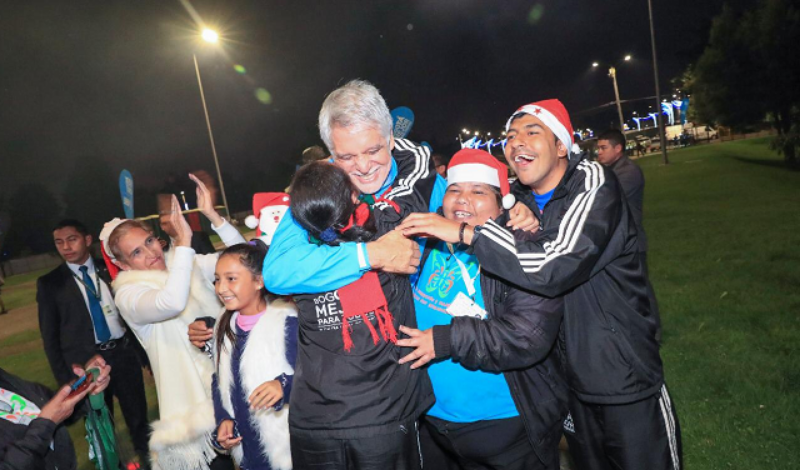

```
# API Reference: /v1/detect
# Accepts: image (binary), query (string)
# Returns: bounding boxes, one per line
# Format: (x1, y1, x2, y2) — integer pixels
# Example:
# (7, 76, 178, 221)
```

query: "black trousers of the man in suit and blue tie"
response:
(99, 335, 150, 458)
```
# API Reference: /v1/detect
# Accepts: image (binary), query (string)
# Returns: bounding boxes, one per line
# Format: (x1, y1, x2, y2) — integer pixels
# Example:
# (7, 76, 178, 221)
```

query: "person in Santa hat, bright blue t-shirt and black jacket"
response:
(398, 149, 566, 469)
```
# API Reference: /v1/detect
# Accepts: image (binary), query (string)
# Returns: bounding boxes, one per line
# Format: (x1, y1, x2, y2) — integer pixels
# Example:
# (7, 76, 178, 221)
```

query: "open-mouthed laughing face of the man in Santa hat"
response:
(505, 114, 567, 194)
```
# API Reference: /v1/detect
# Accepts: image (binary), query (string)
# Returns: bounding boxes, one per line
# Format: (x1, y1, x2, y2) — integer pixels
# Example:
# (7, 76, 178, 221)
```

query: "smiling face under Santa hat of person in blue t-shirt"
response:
(442, 182, 502, 226)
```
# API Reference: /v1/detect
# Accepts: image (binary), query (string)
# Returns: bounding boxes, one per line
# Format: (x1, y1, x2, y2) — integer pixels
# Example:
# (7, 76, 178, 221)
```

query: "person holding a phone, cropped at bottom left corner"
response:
(0, 356, 111, 470)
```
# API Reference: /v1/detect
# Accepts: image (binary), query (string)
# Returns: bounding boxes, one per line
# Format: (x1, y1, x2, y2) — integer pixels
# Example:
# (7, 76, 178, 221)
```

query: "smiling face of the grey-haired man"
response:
(331, 127, 394, 194)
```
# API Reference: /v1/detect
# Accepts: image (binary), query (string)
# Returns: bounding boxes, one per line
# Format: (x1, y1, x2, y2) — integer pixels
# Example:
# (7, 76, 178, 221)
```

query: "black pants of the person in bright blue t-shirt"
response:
(420, 416, 558, 470)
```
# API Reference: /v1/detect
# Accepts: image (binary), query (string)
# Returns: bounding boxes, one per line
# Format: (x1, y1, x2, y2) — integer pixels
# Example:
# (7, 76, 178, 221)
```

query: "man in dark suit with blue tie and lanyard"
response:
(36, 220, 148, 465)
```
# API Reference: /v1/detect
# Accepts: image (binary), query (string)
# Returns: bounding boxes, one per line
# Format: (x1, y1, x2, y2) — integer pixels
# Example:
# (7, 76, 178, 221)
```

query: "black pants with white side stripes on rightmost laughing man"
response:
(564, 385, 683, 470)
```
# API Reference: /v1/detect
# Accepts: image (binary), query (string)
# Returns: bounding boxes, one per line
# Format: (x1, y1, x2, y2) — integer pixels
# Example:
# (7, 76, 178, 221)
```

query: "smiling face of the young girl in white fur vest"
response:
(214, 254, 266, 315)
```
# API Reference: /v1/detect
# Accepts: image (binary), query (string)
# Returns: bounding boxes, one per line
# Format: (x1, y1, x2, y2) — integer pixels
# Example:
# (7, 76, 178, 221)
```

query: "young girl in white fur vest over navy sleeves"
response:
(214, 239, 297, 470)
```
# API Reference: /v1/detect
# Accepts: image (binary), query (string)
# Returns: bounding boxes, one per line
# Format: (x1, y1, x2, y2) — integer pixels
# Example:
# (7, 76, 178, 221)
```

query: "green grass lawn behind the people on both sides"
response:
(0, 140, 800, 470)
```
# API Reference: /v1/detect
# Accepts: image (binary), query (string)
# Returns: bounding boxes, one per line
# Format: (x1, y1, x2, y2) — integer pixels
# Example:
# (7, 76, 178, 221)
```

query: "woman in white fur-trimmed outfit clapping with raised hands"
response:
(100, 175, 244, 470)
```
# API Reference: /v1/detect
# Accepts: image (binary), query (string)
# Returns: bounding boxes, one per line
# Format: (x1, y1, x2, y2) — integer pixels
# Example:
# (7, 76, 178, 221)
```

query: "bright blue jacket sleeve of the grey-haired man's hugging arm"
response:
(264, 209, 369, 295)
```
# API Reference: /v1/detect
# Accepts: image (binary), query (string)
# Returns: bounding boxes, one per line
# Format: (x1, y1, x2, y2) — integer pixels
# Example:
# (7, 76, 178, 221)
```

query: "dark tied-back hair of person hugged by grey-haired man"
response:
(289, 161, 377, 246)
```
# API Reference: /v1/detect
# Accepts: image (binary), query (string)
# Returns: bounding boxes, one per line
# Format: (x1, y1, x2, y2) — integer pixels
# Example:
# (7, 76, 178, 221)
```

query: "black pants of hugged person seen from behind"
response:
(290, 422, 422, 470)
